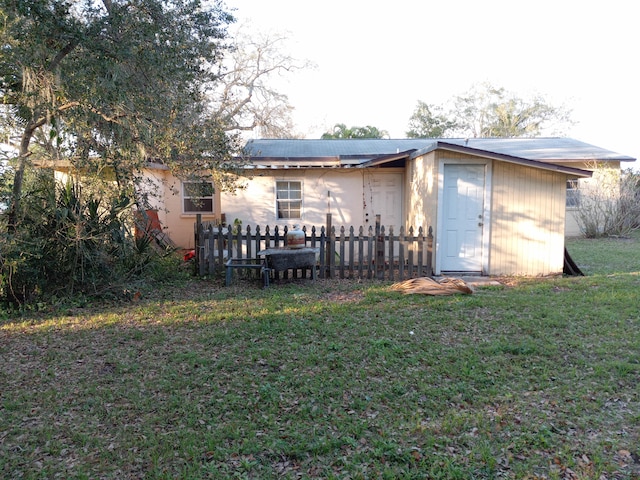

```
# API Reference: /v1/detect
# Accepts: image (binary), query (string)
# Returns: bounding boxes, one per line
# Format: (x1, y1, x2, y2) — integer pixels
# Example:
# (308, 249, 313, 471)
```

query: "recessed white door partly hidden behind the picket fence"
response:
(364, 173, 402, 235)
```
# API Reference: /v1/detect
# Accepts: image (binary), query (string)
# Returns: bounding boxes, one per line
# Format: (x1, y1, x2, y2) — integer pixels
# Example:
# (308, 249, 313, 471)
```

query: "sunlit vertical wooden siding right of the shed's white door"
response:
(489, 162, 567, 275)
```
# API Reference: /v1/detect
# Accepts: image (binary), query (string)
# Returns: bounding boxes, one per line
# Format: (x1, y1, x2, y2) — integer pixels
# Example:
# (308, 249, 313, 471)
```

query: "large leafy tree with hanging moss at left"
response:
(0, 0, 238, 230)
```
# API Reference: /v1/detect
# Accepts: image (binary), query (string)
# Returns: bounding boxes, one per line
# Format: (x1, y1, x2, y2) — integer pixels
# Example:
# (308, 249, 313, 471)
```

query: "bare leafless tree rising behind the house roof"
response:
(210, 28, 310, 138)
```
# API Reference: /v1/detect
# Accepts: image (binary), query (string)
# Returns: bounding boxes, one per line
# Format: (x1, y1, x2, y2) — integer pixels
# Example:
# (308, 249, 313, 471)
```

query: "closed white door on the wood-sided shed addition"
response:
(439, 164, 485, 272)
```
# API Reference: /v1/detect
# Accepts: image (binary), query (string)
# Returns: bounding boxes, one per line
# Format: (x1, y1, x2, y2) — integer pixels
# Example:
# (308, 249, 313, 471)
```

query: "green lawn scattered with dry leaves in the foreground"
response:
(0, 235, 640, 479)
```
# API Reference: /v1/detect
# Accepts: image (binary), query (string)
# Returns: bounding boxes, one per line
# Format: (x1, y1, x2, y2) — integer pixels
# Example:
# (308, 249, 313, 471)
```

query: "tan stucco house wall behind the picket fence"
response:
(144, 168, 404, 248)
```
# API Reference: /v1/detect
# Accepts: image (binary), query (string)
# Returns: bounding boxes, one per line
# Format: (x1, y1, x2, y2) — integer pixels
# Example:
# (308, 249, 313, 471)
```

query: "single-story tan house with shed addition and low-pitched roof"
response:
(142, 138, 634, 275)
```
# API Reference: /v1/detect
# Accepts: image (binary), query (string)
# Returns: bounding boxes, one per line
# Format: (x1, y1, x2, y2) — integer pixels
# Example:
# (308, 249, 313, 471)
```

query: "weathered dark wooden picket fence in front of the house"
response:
(194, 214, 433, 280)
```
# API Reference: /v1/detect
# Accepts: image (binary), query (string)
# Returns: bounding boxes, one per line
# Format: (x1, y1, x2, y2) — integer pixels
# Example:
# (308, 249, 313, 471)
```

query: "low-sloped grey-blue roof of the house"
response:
(245, 138, 635, 168)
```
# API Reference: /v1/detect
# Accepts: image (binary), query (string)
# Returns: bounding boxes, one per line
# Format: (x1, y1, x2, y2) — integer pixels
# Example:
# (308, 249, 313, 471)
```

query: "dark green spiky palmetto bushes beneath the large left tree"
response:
(0, 171, 170, 304)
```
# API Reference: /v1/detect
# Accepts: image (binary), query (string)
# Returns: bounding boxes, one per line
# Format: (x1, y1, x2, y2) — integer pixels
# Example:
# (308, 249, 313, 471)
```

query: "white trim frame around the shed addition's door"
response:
(433, 158, 492, 275)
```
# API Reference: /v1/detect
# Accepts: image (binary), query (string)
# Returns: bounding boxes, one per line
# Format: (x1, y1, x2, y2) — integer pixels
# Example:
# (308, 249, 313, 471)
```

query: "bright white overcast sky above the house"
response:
(225, 0, 640, 165)
